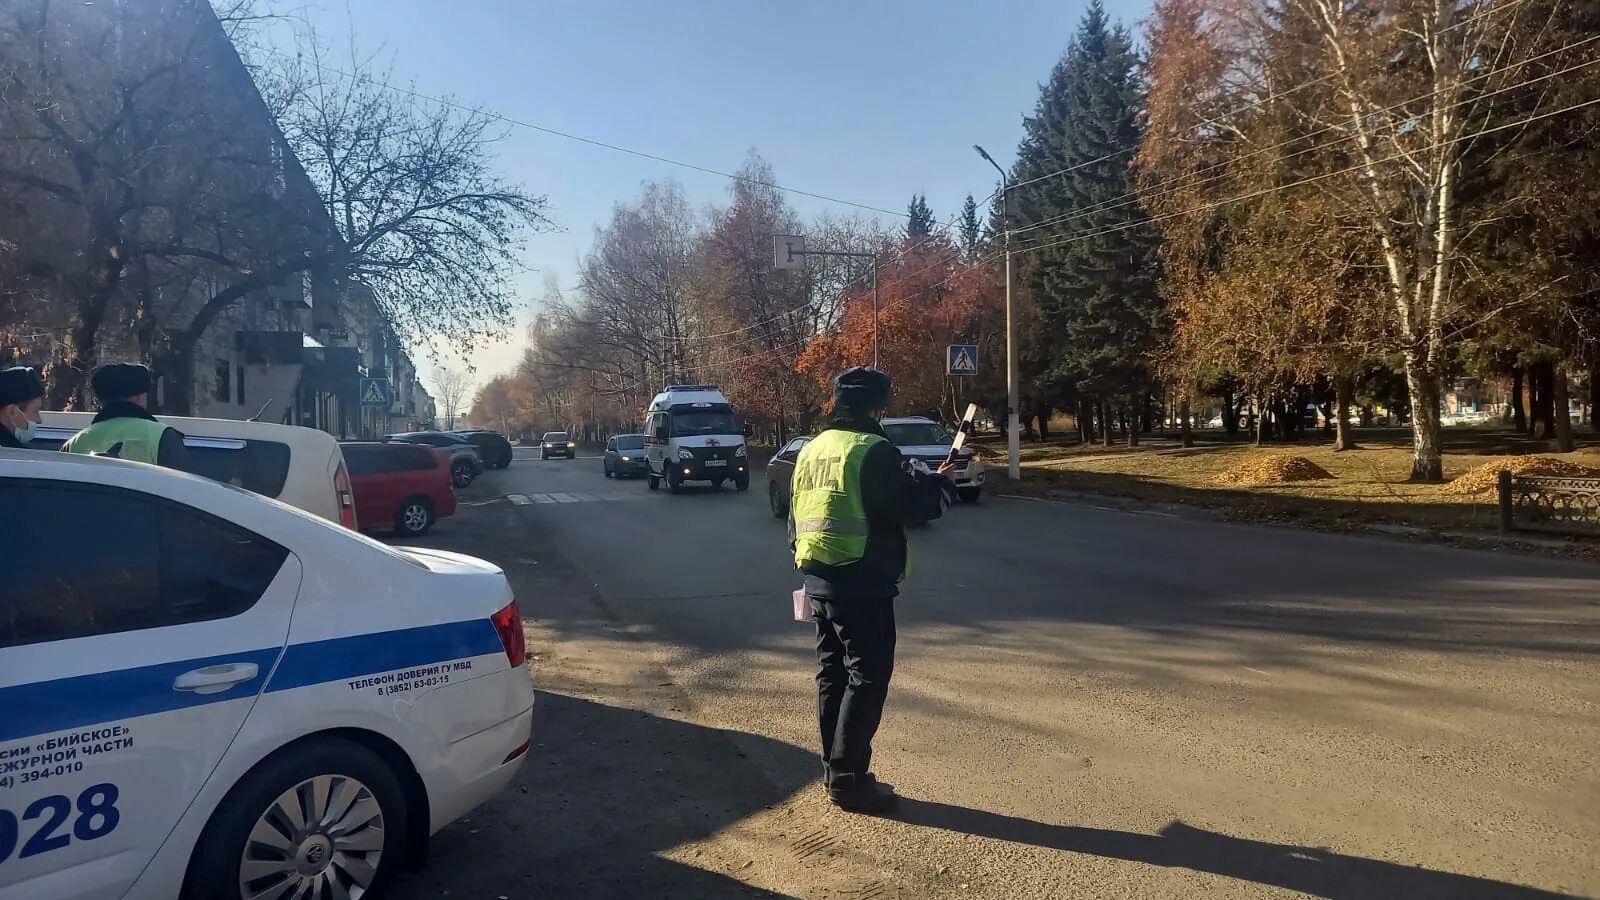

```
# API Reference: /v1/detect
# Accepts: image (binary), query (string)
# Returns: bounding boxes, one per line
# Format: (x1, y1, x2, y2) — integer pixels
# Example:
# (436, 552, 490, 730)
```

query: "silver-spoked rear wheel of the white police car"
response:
(184, 738, 406, 900)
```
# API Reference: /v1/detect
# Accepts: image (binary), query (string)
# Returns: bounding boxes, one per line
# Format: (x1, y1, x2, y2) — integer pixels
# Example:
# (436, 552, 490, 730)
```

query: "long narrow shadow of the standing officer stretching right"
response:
(896, 799, 1573, 900)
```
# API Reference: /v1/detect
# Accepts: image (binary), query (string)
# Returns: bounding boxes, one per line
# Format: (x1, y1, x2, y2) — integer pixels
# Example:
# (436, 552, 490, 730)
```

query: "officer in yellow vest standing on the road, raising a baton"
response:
(789, 367, 949, 812)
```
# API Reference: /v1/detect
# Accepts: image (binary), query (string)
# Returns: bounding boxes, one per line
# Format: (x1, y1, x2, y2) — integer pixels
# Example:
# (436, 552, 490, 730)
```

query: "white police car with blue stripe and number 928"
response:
(0, 450, 533, 900)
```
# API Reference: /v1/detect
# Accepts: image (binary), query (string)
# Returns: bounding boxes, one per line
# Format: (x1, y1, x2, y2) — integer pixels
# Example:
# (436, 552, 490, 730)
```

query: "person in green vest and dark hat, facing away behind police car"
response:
(61, 362, 189, 469)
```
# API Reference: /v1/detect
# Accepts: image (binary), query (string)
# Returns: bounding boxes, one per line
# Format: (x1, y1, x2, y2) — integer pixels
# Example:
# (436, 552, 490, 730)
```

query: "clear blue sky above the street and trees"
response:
(278, 0, 1149, 381)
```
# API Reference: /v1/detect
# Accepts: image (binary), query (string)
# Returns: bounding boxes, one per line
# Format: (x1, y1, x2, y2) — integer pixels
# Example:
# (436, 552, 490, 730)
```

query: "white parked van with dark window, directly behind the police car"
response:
(29, 412, 357, 528)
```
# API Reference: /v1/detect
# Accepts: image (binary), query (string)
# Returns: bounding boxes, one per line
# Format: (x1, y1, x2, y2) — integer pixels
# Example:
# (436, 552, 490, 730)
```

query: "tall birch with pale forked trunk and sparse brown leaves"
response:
(1282, 0, 1580, 482)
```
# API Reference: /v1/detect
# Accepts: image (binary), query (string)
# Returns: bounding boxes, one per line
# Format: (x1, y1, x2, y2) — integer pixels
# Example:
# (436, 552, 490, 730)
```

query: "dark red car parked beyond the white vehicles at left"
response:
(339, 440, 456, 536)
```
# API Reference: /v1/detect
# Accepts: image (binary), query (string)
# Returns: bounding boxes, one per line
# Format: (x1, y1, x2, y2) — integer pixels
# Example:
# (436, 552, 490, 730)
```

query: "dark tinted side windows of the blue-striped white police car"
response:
(0, 480, 288, 647)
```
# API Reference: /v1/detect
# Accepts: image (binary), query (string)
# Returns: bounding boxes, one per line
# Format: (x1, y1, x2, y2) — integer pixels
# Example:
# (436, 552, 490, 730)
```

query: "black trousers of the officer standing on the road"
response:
(808, 597, 894, 780)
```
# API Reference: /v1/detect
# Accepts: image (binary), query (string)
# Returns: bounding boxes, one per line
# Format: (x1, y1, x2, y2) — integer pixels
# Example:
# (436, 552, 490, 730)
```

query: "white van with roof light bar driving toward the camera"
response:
(645, 377, 750, 493)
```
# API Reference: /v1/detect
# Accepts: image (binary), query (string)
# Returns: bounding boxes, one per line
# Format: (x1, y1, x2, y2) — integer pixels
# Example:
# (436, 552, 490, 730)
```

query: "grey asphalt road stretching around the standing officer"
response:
(398, 456, 1600, 900)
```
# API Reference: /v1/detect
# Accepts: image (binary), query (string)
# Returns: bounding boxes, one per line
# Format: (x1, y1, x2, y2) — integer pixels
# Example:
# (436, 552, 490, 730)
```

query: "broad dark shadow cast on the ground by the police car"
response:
(392, 692, 816, 900)
